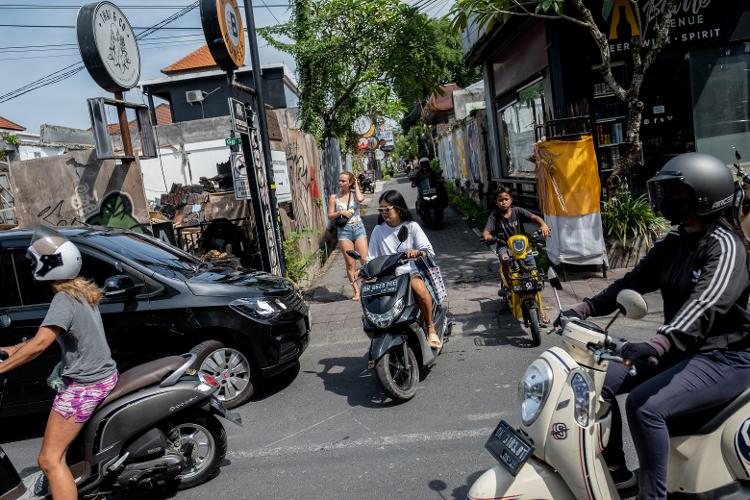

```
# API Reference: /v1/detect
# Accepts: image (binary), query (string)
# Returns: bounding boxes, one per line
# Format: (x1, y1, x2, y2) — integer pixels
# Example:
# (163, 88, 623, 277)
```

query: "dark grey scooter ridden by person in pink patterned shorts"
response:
(0, 317, 241, 500)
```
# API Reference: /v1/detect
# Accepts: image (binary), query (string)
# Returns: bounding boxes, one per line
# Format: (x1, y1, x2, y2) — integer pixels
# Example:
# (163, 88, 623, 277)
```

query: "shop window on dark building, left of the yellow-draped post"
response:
(498, 80, 544, 176)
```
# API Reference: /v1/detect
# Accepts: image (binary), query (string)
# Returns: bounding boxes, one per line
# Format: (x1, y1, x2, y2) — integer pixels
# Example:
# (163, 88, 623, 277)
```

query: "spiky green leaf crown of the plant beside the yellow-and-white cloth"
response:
(602, 191, 669, 247)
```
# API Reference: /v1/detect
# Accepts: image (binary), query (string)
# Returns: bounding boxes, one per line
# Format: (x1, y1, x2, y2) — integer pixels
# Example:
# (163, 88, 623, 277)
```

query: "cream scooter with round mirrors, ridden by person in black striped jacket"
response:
(468, 269, 750, 500)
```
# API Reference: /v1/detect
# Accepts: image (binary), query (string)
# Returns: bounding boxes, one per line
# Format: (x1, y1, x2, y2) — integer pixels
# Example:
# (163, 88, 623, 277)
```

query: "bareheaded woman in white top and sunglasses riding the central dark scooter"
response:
(367, 189, 442, 349)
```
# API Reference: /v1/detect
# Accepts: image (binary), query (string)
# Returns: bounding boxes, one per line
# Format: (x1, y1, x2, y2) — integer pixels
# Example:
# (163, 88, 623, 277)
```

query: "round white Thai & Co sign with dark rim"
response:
(76, 2, 141, 92)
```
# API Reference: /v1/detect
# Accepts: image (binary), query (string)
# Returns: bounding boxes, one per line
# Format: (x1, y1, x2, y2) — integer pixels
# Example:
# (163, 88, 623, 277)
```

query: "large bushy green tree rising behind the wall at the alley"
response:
(259, 0, 478, 148)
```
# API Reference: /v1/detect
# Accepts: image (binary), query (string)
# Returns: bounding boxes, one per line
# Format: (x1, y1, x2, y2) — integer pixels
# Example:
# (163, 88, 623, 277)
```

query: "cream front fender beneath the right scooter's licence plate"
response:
(467, 457, 575, 500)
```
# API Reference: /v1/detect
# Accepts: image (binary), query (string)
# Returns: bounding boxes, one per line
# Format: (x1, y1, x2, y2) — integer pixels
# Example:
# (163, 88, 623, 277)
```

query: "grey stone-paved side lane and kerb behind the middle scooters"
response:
(306, 176, 636, 345)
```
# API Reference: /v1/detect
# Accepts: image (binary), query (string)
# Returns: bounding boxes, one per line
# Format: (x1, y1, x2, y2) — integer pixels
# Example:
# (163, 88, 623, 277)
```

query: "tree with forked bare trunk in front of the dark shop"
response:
(451, 0, 680, 193)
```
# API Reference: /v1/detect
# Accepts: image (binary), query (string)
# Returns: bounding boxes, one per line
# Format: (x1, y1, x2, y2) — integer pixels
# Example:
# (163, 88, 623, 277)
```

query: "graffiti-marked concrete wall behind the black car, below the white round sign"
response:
(9, 151, 150, 231)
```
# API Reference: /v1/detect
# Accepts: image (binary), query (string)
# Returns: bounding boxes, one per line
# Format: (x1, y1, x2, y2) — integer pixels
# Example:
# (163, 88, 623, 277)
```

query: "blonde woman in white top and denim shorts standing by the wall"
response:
(328, 172, 367, 300)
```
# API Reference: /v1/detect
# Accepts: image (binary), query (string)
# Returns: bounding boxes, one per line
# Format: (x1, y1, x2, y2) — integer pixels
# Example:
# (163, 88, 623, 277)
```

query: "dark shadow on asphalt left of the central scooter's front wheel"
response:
(309, 355, 394, 408)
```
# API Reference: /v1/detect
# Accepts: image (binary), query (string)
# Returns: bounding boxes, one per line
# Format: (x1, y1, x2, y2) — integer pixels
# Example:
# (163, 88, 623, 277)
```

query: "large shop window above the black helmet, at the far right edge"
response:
(690, 44, 750, 162)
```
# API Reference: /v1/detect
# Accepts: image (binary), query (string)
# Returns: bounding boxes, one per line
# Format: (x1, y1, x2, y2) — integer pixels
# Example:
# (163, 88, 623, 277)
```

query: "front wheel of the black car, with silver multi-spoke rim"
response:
(190, 340, 258, 409)
